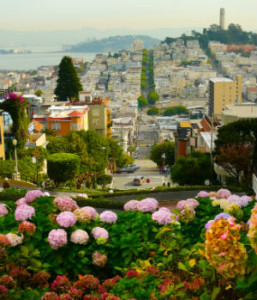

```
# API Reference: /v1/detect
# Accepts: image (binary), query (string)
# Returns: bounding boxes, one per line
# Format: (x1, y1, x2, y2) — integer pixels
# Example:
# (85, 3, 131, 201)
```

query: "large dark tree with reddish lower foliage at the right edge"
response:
(214, 119, 257, 186)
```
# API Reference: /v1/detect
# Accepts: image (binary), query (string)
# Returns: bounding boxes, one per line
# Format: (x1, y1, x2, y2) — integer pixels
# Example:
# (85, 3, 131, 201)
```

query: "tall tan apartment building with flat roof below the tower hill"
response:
(209, 75, 242, 116)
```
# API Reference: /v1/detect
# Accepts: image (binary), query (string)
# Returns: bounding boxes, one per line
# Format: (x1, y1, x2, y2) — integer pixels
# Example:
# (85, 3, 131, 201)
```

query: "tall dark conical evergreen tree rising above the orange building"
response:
(54, 56, 82, 101)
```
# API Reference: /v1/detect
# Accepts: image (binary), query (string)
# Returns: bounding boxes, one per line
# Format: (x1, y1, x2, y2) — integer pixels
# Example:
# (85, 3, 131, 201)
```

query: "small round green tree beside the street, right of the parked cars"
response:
(150, 141, 175, 167)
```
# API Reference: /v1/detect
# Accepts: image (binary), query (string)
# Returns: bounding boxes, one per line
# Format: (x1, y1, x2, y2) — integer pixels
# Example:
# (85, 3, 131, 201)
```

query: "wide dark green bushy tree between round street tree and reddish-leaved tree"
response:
(170, 151, 215, 185)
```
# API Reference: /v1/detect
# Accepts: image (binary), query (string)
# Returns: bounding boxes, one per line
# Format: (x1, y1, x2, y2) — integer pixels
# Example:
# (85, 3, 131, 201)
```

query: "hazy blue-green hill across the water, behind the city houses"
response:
(68, 35, 160, 52)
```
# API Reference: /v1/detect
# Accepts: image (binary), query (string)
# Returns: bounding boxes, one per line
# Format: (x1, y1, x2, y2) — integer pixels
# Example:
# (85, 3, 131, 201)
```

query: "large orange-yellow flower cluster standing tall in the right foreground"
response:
(205, 217, 247, 279)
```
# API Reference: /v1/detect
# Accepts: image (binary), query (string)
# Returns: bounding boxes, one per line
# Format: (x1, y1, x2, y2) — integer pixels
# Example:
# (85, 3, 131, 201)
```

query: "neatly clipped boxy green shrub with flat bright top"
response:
(47, 153, 80, 186)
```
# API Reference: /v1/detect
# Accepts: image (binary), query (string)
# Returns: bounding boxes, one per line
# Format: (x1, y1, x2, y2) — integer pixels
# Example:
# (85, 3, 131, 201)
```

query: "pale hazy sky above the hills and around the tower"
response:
(0, 0, 257, 31)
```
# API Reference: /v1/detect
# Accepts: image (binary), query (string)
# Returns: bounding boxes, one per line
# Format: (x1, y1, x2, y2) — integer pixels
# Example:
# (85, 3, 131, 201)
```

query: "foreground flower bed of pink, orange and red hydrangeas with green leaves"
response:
(0, 189, 257, 300)
